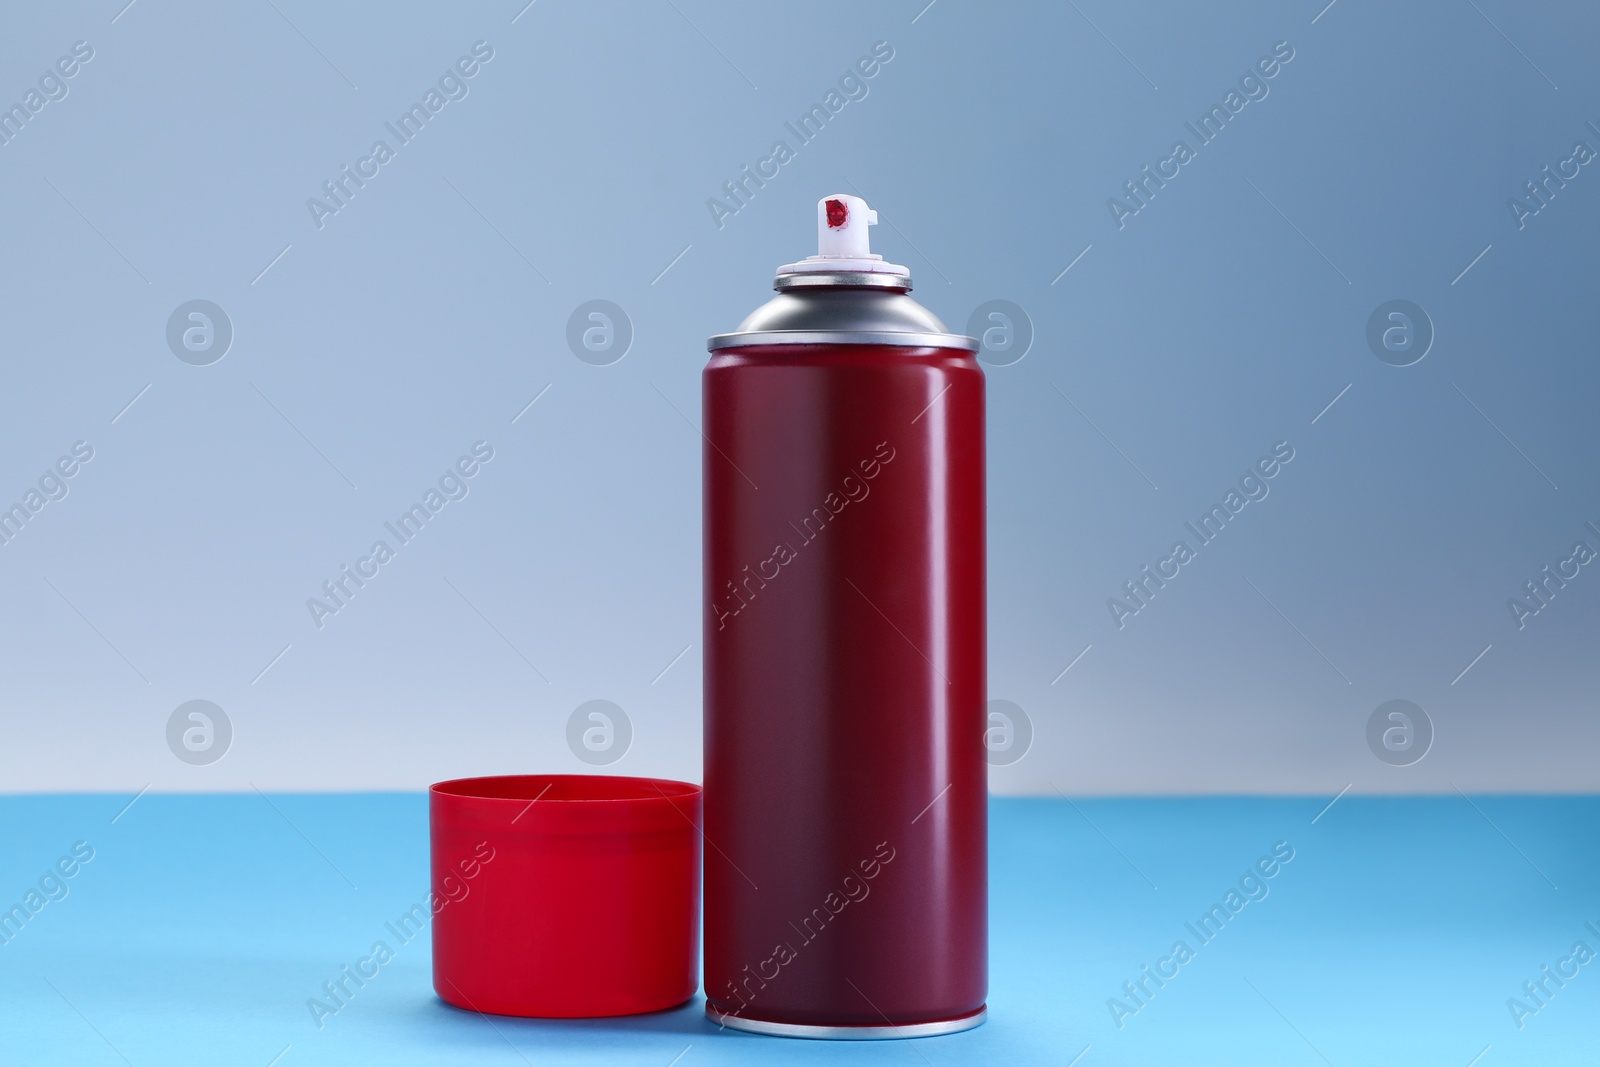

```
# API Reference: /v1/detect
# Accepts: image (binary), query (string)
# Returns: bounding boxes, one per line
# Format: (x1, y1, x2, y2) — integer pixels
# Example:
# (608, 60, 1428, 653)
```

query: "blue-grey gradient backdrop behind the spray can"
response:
(0, 0, 1600, 795)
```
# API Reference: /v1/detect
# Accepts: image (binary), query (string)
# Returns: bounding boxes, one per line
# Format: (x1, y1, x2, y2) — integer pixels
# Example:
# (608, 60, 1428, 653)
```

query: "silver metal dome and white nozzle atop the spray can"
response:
(706, 195, 978, 352)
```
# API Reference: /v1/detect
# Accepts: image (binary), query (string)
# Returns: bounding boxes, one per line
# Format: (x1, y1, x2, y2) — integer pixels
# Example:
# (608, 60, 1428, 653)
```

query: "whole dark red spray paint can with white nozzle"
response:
(702, 195, 989, 1038)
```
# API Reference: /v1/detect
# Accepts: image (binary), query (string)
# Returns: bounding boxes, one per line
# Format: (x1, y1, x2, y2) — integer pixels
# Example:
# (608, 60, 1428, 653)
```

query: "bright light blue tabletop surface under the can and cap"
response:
(0, 793, 1600, 1067)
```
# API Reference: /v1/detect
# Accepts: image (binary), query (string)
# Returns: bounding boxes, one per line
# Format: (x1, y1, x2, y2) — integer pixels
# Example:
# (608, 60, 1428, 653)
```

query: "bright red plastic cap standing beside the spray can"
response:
(429, 774, 701, 1019)
